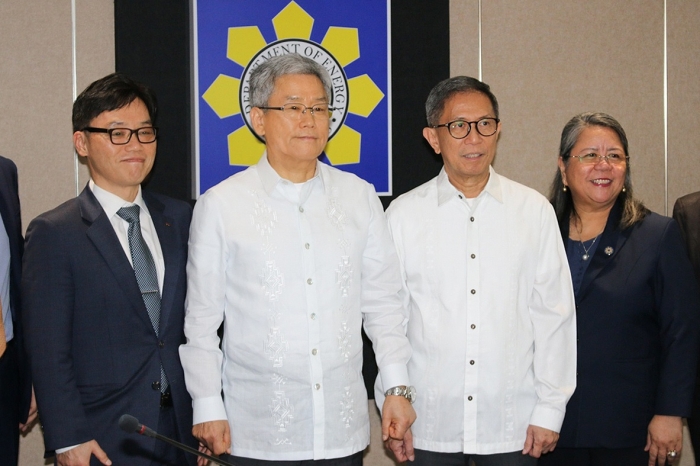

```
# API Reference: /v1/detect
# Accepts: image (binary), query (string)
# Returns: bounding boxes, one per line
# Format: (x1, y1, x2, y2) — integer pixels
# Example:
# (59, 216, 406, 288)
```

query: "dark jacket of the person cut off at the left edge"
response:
(0, 157, 32, 422)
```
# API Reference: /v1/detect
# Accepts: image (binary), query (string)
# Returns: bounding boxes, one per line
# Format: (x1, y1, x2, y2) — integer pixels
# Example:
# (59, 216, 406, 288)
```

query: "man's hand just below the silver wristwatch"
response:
(382, 395, 416, 462)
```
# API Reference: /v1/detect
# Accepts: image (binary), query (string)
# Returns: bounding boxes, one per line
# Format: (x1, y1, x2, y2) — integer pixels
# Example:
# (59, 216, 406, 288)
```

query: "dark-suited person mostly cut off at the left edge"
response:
(0, 157, 36, 466)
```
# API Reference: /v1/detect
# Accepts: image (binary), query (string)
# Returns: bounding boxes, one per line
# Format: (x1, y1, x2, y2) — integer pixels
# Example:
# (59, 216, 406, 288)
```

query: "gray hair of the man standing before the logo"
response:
(250, 53, 332, 107)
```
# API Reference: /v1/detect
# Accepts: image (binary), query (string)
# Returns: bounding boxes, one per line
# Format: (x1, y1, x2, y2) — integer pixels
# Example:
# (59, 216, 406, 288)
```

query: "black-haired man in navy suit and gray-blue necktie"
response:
(22, 74, 196, 466)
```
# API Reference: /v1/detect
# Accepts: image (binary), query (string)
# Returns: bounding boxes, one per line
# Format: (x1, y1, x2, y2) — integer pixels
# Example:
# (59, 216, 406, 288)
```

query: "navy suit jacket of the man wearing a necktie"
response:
(22, 188, 196, 466)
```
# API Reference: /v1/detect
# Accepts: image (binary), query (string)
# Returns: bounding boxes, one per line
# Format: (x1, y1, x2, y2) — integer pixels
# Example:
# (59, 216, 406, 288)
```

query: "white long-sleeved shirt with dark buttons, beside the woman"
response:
(376, 168, 576, 454)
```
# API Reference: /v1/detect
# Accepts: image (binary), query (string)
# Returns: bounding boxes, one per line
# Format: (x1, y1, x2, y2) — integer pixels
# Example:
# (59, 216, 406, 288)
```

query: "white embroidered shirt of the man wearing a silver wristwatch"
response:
(180, 155, 411, 460)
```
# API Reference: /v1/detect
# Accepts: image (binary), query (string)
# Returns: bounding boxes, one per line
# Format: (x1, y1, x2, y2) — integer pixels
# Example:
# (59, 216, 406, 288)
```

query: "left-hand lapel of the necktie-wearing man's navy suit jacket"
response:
(78, 187, 153, 328)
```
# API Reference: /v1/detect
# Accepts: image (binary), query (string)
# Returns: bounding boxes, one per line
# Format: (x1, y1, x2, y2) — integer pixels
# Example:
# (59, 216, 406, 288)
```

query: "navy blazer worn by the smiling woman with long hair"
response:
(557, 203, 700, 448)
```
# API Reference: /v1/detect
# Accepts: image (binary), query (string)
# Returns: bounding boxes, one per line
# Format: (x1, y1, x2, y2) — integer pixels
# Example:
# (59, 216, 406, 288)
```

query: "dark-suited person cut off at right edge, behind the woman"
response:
(673, 191, 700, 456)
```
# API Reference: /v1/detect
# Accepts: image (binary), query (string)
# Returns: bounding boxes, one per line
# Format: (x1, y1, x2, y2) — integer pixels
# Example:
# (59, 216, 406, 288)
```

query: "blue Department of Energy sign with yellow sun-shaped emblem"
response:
(195, 0, 391, 195)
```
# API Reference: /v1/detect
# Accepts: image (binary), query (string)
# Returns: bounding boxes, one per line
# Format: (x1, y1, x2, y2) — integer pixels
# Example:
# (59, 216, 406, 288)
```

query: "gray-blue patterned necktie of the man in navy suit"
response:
(117, 205, 168, 393)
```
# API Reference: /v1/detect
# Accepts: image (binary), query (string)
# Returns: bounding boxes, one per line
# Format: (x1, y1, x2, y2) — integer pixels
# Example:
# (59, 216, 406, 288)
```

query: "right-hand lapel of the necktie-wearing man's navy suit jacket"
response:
(142, 192, 181, 335)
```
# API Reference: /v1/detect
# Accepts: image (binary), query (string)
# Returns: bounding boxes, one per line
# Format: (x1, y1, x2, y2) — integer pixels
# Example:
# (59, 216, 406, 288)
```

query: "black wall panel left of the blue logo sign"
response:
(114, 0, 192, 200)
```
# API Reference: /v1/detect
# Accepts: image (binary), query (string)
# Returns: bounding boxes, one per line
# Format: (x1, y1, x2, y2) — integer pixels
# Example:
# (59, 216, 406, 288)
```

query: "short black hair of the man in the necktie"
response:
(73, 73, 158, 132)
